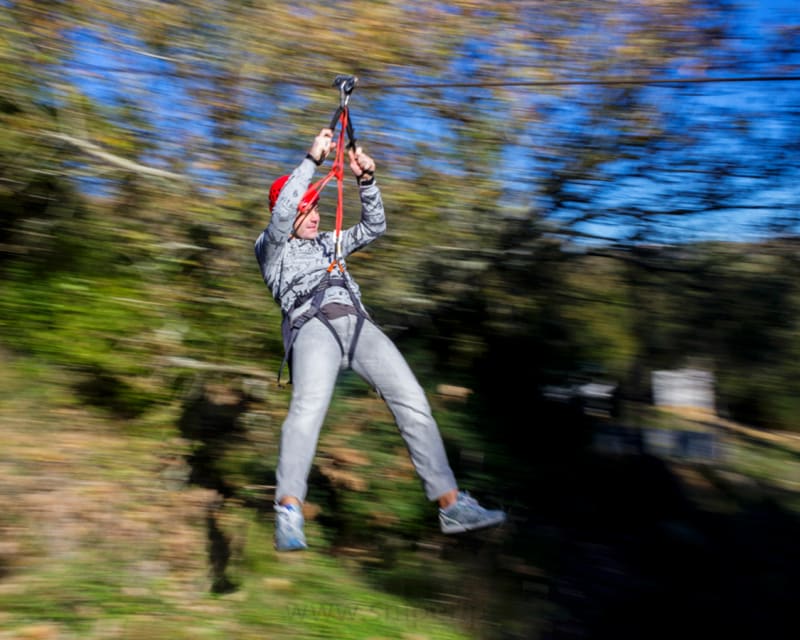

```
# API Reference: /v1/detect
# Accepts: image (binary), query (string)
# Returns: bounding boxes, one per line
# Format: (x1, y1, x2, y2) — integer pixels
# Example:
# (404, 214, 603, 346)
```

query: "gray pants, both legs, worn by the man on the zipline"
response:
(275, 315, 457, 502)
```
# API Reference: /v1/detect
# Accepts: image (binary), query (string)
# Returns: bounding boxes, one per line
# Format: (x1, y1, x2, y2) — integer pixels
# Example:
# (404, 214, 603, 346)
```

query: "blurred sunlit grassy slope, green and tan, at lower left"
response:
(0, 354, 476, 640)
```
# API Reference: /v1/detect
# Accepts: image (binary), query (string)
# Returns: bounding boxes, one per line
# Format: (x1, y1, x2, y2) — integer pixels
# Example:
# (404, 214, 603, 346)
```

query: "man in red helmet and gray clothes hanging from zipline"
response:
(255, 128, 506, 551)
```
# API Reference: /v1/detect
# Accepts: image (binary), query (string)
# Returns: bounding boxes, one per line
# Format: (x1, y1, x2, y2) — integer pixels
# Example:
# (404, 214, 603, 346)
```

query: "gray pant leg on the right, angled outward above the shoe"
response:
(345, 316, 457, 500)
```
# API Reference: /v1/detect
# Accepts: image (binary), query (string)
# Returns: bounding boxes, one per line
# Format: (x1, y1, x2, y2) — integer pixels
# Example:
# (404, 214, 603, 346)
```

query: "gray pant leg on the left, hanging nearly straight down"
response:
(275, 318, 342, 502)
